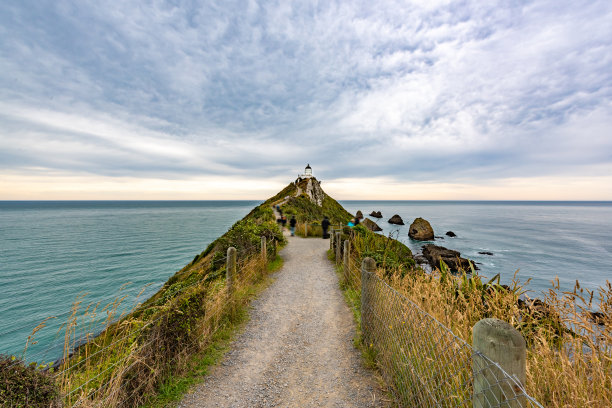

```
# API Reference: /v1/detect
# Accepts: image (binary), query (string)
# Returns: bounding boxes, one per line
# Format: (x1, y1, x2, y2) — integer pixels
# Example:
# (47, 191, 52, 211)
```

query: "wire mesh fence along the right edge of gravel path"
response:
(331, 231, 541, 408)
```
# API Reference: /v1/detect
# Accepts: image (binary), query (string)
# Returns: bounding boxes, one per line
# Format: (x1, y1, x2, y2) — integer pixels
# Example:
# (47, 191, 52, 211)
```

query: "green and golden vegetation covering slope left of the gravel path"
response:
(43, 203, 286, 407)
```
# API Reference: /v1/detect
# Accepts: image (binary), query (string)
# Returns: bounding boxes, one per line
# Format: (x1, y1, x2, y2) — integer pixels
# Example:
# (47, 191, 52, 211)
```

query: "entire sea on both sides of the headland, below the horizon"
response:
(0, 200, 612, 362)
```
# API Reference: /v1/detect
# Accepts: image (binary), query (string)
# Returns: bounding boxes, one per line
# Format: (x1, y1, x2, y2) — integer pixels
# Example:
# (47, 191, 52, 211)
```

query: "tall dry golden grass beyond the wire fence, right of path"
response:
(343, 230, 612, 407)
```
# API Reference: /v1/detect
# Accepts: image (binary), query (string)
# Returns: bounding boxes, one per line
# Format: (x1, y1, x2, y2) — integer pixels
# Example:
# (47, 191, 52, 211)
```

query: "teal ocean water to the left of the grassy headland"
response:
(0, 201, 258, 361)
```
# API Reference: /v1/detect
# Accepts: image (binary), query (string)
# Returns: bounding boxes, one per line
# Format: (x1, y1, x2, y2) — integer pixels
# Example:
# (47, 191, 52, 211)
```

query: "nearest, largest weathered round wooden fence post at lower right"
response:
(472, 318, 527, 408)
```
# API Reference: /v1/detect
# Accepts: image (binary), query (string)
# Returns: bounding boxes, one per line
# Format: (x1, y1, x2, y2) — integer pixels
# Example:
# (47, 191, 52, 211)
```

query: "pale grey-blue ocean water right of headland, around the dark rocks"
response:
(340, 201, 612, 297)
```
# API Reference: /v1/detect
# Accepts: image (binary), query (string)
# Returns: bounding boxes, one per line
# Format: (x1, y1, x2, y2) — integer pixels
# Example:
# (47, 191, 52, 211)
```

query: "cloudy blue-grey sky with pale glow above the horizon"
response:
(0, 0, 612, 200)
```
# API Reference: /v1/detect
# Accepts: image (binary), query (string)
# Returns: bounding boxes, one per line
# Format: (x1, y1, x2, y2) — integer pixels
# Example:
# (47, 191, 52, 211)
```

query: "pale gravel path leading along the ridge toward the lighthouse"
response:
(179, 233, 387, 408)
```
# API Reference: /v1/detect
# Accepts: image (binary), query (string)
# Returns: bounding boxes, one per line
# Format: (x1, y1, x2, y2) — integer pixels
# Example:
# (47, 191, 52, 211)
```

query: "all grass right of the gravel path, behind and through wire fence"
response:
(329, 229, 612, 407)
